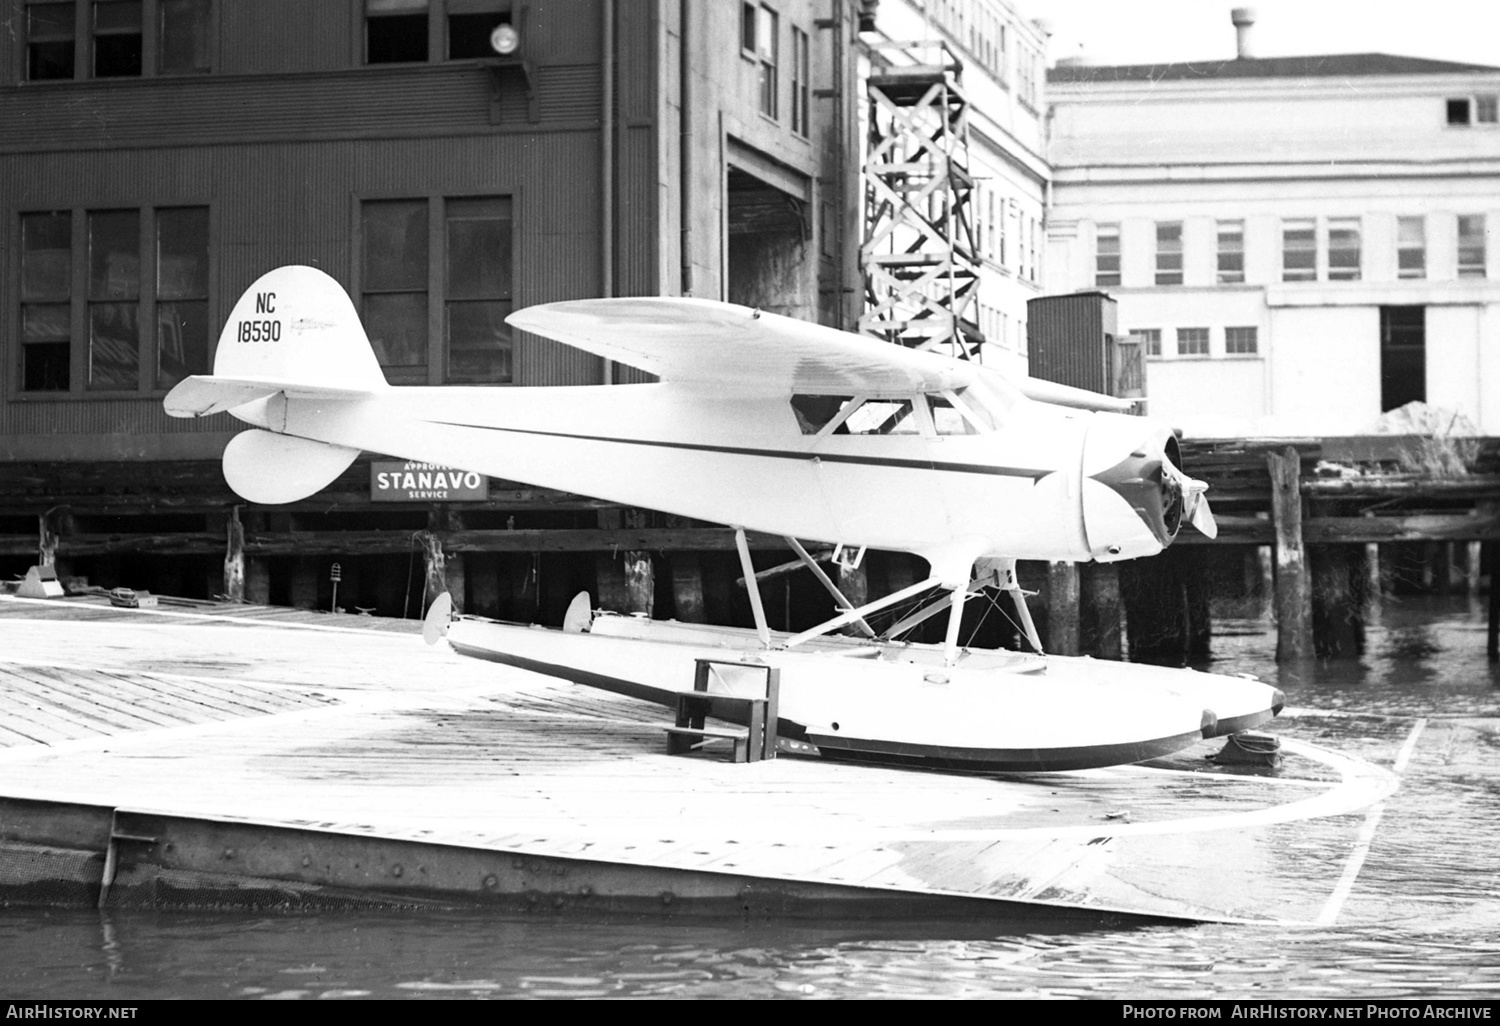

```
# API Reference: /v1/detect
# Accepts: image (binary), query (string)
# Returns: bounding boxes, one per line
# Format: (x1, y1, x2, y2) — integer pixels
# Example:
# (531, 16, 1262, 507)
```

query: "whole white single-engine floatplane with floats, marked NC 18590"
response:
(165, 267, 1283, 771)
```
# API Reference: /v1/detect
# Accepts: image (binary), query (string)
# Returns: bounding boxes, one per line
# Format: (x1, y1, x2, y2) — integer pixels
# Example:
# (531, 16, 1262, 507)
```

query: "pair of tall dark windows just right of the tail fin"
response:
(360, 197, 513, 384)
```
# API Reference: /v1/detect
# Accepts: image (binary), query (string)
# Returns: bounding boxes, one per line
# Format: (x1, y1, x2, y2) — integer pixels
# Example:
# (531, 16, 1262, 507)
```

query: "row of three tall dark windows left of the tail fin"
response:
(20, 207, 210, 392)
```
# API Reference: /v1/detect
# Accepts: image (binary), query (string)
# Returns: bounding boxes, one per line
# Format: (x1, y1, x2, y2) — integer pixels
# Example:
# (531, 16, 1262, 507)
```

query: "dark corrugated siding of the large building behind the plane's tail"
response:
(0, 0, 659, 459)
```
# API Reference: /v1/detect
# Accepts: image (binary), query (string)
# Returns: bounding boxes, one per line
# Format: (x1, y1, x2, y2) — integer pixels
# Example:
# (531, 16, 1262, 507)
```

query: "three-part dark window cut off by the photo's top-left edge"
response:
(26, 0, 212, 81)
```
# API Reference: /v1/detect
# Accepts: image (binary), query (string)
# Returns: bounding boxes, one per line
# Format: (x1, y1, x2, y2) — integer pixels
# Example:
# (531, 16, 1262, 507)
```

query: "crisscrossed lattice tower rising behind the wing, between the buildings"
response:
(860, 42, 984, 359)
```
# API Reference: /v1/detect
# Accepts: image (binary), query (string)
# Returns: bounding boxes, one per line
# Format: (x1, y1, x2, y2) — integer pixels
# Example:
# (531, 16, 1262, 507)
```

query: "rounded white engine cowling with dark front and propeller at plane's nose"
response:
(1082, 413, 1215, 563)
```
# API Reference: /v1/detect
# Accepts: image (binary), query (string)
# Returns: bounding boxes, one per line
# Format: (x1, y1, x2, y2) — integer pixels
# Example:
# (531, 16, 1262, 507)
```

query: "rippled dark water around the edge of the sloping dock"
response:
(0, 599, 1500, 1002)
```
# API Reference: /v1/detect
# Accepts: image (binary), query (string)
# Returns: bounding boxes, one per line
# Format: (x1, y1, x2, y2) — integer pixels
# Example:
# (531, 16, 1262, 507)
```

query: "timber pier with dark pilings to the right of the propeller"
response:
(1124, 435, 1500, 660)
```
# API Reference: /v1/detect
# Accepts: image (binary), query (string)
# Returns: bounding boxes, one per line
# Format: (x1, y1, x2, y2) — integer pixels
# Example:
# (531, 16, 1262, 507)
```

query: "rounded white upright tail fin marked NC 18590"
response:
(213, 266, 386, 390)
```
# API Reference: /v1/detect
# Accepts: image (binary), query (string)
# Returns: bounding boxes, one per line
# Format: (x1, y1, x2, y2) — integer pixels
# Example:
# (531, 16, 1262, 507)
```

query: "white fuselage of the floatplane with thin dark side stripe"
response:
(234, 384, 1161, 573)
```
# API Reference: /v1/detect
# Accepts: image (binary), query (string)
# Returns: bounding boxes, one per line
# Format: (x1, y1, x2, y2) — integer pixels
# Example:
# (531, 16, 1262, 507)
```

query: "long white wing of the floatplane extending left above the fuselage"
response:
(506, 297, 981, 395)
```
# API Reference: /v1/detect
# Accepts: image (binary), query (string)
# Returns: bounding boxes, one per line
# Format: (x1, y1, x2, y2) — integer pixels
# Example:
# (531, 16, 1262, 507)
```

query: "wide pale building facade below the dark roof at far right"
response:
(1047, 24, 1500, 435)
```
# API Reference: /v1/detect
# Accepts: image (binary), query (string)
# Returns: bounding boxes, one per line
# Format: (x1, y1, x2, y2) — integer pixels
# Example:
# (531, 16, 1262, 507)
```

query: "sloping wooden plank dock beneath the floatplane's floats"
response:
(0, 599, 1395, 921)
